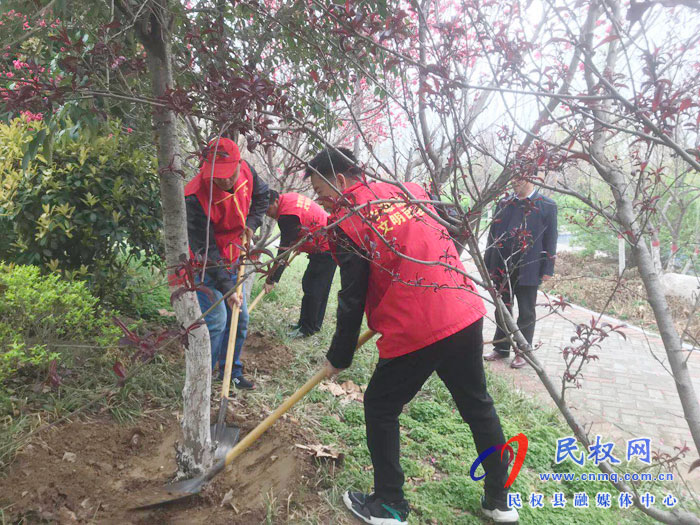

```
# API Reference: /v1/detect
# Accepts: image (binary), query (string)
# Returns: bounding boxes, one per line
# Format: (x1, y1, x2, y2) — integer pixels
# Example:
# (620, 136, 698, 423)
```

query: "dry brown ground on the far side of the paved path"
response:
(541, 253, 700, 344)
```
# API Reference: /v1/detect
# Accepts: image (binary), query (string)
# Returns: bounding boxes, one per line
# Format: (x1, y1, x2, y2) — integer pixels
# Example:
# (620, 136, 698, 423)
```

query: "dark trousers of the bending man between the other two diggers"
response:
(299, 252, 336, 334)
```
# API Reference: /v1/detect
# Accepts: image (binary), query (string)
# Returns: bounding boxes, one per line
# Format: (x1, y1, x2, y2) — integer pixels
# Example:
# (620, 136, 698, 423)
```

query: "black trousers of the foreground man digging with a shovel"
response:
(364, 319, 508, 501)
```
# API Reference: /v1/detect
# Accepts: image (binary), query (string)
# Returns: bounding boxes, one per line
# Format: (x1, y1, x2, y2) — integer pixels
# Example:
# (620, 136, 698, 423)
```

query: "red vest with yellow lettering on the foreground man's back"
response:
(329, 182, 486, 358)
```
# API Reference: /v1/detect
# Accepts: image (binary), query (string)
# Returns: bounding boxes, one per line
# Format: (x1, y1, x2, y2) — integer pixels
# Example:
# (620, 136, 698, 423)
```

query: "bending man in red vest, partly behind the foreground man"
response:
(265, 190, 336, 337)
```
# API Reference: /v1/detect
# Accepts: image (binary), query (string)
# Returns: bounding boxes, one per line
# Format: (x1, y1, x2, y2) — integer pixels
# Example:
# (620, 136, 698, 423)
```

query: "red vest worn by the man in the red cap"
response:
(185, 161, 253, 264)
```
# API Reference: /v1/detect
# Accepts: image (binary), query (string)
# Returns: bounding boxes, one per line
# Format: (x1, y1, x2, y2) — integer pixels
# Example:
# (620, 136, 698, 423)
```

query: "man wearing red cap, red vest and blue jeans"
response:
(185, 138, 268, 389)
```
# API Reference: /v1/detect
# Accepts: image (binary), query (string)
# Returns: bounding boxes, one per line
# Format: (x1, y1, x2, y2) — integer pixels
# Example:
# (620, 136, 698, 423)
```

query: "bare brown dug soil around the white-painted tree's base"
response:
(0, 333, 328, 524)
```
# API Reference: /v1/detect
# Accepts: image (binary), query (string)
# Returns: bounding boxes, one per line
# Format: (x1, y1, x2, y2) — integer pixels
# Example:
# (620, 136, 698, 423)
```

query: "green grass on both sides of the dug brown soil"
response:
(0, 253, 678, 525)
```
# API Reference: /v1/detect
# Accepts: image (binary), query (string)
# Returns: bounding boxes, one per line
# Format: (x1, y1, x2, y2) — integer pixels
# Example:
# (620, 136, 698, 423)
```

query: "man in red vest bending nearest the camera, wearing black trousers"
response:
(306, 148, 518, 525)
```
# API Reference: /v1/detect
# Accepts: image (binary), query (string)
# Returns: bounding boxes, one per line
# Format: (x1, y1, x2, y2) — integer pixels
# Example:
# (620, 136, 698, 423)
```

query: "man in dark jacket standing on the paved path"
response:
(484, 178, 557, 368)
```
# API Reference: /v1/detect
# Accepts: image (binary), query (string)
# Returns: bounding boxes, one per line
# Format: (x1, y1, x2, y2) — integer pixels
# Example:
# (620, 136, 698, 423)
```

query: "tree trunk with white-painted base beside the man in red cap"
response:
(139, 1, 213, 477)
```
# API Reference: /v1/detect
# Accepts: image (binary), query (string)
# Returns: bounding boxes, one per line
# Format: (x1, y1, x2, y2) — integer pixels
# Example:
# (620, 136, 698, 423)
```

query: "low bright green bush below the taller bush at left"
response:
(0, 264, 120, 384)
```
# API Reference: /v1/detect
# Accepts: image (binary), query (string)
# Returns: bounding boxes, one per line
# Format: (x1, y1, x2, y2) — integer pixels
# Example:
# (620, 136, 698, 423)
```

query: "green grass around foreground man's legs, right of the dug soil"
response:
(249, 257, 688, 525)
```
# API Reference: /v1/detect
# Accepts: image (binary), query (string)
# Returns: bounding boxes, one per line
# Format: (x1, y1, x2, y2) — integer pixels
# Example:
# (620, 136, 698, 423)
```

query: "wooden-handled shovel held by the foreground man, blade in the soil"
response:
(132, 330, 376, 510)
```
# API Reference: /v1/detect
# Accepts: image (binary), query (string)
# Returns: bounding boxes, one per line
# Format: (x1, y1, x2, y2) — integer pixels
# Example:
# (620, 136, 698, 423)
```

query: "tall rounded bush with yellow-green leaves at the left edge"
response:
(0, 119, 162, 297)
